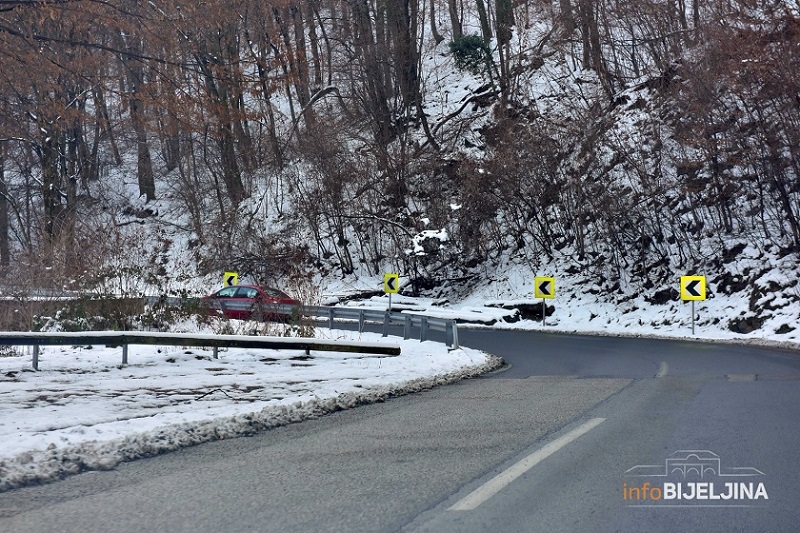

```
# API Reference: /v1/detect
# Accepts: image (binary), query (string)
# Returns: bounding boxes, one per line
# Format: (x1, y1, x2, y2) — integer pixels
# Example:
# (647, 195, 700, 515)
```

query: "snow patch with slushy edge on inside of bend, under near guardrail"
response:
(0, 328, 500, 490)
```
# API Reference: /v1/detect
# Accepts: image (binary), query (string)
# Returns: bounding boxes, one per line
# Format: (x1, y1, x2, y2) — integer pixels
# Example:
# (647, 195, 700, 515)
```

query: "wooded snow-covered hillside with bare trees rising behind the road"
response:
(2, 1, 800, 338)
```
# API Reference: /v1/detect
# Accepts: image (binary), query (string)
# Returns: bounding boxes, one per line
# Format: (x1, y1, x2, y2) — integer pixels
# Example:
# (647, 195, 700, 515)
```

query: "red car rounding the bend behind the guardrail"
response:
(203, 285, 300, 320)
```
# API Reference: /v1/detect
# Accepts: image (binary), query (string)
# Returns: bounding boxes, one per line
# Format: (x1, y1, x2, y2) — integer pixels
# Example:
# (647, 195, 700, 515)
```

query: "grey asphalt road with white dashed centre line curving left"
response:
(0, 330, 800, 532)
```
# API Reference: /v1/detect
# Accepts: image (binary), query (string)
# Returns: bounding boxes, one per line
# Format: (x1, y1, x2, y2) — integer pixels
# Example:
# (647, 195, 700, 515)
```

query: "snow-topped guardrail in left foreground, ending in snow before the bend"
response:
(0, 331, 400, 370)
